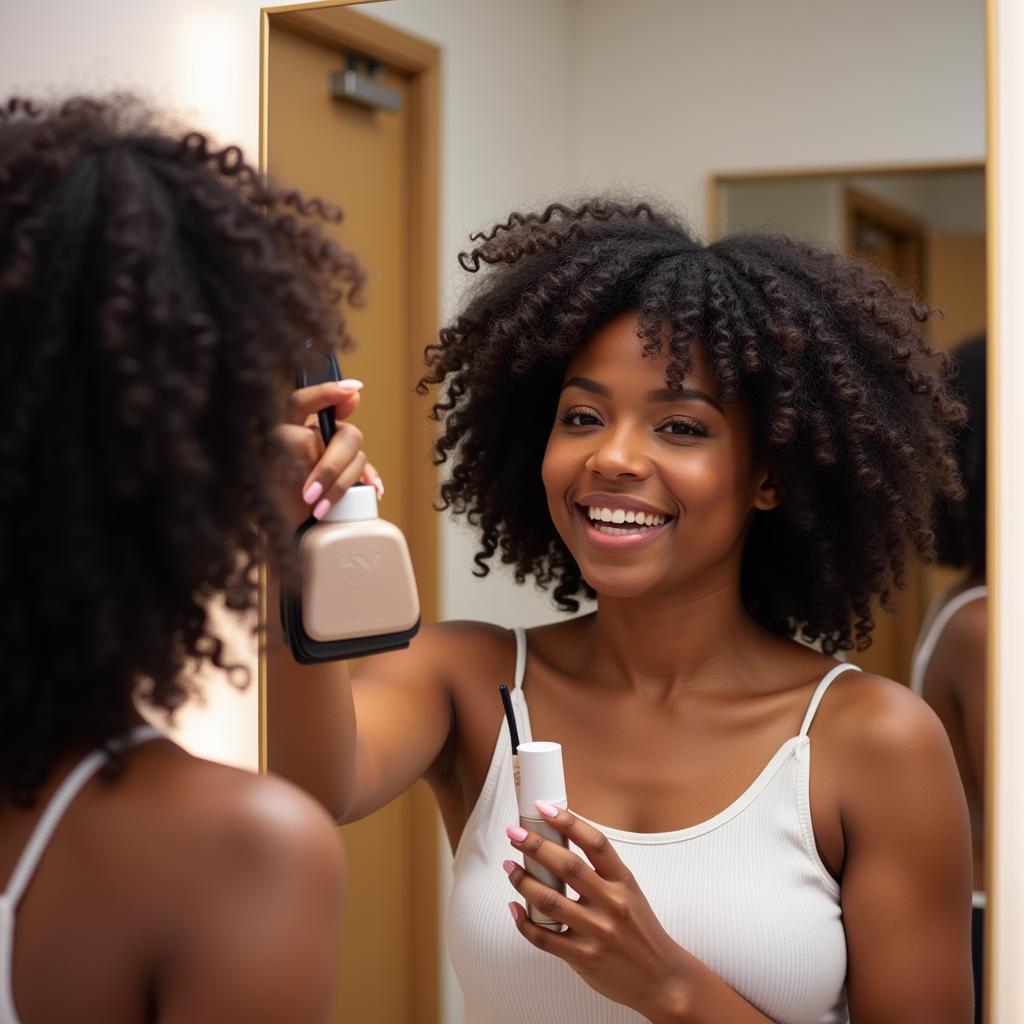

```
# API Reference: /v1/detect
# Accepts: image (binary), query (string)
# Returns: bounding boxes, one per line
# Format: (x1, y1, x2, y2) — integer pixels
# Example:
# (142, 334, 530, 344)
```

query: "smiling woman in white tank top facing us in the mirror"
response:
(269, 202, 971, 1024)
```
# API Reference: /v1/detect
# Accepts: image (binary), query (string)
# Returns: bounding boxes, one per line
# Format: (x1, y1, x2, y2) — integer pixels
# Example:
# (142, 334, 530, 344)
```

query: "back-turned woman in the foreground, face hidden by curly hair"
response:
(0, 98, 358, 1024)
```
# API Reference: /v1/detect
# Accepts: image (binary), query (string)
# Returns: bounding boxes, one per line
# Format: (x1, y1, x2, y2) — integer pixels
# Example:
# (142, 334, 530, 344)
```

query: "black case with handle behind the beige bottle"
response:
(281, 346, 420, 665)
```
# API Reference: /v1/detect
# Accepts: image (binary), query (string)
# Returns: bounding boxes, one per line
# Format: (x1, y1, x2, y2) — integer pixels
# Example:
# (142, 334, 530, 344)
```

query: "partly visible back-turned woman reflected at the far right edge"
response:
(910, 334, 988, 1022)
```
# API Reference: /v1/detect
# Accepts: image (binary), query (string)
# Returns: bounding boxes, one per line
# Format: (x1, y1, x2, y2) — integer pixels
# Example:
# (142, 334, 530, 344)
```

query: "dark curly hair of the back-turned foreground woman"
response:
(0, 96, 361, 806)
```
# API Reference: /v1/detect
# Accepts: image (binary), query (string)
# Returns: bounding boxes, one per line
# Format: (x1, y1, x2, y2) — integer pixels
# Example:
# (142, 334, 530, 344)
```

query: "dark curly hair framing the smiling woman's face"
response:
(420, 199, 964, 653)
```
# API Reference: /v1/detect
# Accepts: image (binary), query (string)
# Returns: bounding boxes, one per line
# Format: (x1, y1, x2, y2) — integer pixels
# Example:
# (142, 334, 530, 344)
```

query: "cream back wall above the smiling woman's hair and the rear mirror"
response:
(572, 0, 985, 230)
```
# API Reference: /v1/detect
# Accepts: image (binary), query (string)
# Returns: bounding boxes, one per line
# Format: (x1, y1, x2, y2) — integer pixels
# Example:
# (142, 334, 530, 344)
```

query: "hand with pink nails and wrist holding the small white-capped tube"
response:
(504, 802, 693, 1020)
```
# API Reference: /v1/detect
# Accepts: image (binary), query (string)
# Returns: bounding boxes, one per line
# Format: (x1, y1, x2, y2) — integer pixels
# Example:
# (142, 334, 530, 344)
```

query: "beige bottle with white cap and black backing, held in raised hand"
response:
(281, 346, 420, 665)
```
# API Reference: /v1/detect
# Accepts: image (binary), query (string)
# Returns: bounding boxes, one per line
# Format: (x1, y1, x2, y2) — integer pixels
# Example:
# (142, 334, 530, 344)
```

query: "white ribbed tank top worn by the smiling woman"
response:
(447, 630, 859, 1024)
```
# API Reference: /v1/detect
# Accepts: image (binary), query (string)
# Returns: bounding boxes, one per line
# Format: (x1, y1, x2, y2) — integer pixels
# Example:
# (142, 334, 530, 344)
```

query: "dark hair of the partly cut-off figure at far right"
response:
(935, 334, 988, 575)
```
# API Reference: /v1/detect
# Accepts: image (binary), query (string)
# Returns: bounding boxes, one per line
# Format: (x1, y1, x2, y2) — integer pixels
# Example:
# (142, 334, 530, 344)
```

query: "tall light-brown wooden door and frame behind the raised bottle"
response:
(263, 7, 439, 1024)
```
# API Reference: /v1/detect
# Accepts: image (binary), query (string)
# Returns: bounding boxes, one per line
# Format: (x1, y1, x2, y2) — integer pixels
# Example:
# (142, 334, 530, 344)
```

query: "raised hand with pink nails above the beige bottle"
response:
(278, 380, 384, 528)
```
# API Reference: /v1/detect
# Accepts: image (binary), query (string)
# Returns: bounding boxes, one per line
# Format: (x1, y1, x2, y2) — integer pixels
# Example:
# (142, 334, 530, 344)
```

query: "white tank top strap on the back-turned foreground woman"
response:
(0, 725, 166, 1024)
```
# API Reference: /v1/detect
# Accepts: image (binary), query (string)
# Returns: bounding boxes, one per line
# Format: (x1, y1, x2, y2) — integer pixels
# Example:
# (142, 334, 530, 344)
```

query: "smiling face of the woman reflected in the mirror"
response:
(543, 312, 777, 597)
